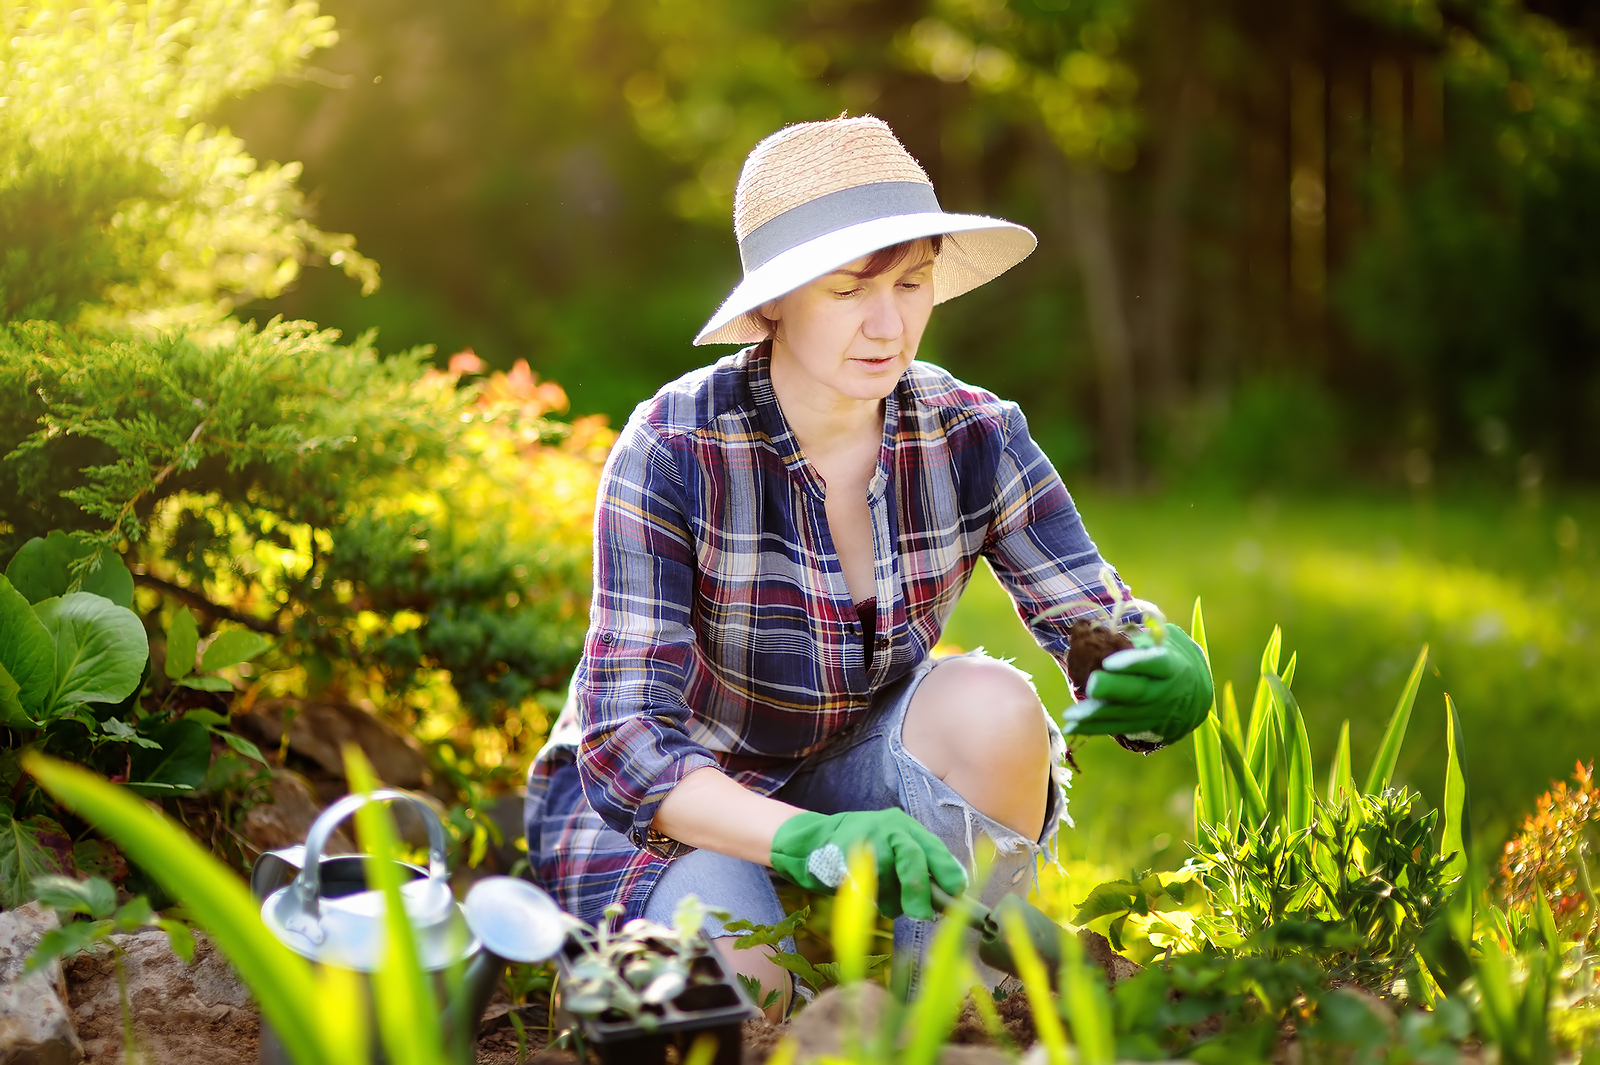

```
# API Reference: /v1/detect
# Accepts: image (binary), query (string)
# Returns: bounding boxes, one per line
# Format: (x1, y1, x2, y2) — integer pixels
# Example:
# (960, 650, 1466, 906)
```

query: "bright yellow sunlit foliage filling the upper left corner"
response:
(0, 0, 378, 326)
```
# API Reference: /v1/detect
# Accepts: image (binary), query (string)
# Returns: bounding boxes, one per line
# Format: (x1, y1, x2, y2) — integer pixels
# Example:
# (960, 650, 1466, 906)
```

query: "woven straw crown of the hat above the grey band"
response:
(733, 115, 933, 240)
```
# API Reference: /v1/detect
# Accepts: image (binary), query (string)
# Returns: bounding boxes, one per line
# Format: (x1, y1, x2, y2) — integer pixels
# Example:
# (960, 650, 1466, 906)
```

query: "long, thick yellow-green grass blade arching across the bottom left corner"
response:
(22, 752, 328, 1065)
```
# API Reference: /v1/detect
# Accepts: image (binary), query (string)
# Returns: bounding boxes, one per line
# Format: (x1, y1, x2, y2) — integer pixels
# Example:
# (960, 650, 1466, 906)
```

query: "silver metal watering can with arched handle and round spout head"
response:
(250, 788, 571, 1065)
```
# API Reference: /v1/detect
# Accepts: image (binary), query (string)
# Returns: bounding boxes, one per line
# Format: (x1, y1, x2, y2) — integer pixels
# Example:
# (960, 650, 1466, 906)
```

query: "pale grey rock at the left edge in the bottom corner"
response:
(0, 902, 83, 1065)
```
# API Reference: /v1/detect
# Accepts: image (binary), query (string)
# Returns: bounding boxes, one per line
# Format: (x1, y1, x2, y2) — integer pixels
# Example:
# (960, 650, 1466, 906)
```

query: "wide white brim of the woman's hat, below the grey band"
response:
(694, 211, 1038, 344)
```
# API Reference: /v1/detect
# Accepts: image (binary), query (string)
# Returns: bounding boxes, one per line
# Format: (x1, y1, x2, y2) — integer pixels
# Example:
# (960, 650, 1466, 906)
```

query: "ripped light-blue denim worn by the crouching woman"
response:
(645, 651, 1072, 988)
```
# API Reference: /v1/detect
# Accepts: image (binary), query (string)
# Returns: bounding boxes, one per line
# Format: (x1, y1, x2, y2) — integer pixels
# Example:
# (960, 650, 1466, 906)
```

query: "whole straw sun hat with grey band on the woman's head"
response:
(694, 115, 1038, 344)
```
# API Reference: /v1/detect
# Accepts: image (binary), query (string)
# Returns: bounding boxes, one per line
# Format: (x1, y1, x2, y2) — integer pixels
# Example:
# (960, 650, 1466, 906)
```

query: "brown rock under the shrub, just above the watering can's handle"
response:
(234, 699, 432, 793)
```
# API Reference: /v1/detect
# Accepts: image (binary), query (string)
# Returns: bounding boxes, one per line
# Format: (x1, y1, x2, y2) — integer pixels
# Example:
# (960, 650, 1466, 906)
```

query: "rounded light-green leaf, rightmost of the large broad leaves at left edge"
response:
(34, 592, 150, 715)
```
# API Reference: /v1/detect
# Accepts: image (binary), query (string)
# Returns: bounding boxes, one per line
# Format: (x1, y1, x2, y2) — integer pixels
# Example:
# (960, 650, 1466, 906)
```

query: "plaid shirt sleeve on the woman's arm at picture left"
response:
(574, 417, 718, 857)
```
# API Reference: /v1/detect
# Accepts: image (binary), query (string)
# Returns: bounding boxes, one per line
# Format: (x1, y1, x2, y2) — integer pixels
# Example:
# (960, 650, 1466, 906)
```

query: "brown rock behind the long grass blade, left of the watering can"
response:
(66, 929, 261, 1065)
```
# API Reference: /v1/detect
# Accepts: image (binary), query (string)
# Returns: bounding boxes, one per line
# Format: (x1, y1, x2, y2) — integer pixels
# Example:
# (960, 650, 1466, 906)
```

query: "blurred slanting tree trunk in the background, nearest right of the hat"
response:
(1040, 136, 1138, 488)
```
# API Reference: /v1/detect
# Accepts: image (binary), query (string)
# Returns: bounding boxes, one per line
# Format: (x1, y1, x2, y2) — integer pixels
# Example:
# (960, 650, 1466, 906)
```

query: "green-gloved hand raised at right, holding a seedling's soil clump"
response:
(1064, 622, 1211, 745)
